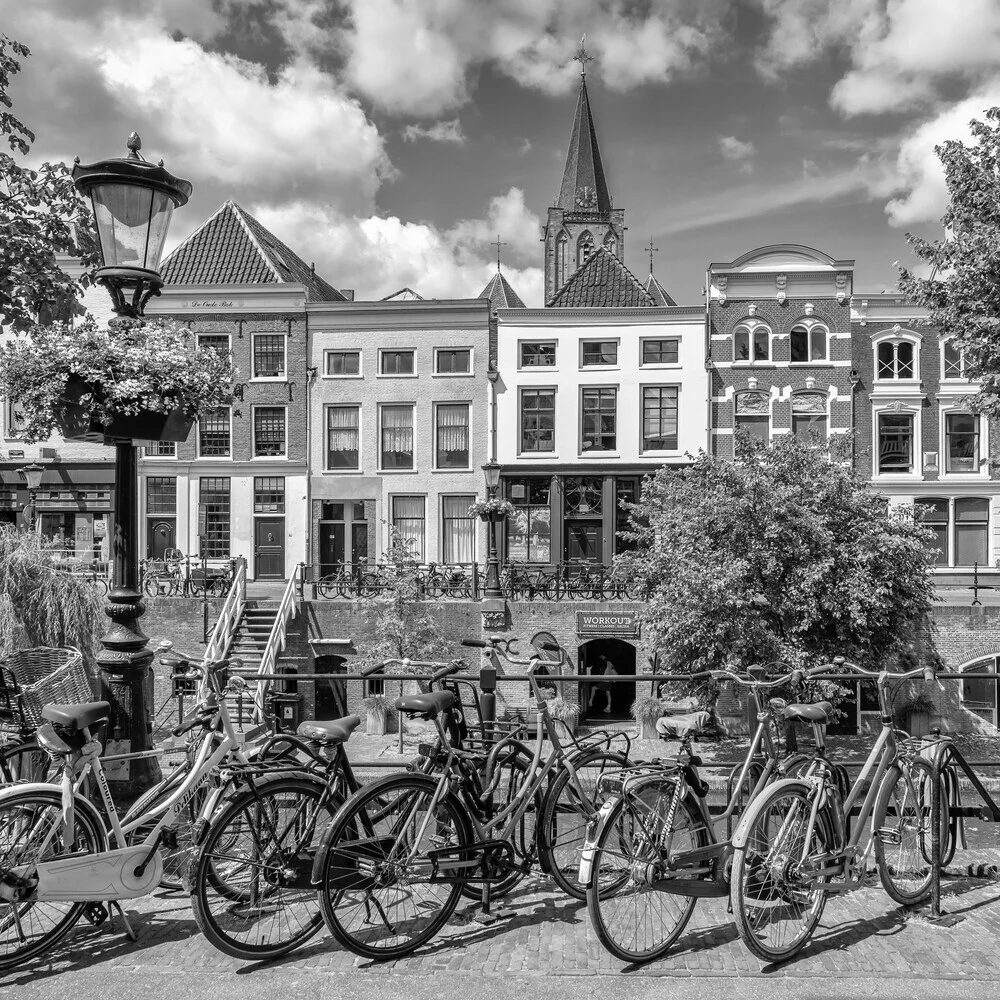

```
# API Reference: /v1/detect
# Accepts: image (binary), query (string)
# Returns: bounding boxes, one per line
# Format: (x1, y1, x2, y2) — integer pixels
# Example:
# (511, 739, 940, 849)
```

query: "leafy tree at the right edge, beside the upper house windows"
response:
(899, 108, 1000, 416)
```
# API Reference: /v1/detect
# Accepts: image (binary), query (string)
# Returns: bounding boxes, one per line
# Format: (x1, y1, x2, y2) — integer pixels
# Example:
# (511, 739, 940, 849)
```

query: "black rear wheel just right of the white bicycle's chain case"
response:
(189, 777, 340, 961)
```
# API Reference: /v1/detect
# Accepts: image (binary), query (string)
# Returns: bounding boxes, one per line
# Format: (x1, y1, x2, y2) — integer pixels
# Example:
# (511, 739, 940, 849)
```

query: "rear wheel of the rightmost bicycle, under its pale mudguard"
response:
(731, 782, 835, 962)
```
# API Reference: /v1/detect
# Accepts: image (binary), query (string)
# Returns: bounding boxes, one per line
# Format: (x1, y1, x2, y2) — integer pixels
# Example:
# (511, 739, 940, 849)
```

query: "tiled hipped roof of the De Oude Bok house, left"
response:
(160, 200, 347, 302)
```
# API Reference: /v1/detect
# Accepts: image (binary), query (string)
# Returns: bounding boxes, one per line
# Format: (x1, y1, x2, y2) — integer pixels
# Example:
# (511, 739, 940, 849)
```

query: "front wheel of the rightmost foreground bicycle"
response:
(872, 760, 936, 906)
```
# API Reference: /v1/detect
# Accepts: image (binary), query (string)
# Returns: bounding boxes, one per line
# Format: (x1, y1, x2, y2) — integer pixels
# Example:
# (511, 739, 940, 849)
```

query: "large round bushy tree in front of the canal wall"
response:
(619, 437, 934, 672)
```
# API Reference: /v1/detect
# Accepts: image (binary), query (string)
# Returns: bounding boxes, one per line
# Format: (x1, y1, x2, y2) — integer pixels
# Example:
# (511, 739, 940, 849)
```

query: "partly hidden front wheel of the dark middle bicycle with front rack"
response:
(538, 750, 628, 899)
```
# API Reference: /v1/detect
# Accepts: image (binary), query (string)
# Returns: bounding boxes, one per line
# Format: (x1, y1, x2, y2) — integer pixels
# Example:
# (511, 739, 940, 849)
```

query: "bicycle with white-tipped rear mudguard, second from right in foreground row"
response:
(580, 664, 808, 962)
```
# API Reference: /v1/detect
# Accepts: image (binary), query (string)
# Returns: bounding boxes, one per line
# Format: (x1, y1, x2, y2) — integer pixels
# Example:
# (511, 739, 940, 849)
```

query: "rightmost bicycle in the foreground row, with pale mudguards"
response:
(732, 658, 947, 962)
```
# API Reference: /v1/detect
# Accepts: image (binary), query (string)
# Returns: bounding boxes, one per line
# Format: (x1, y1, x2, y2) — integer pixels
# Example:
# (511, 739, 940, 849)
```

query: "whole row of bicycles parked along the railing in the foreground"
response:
(0, 639, 972, 969)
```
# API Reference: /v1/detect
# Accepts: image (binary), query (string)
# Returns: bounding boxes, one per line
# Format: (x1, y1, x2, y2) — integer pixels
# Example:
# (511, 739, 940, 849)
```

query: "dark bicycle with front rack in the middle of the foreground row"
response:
(314, 640, 622, 959)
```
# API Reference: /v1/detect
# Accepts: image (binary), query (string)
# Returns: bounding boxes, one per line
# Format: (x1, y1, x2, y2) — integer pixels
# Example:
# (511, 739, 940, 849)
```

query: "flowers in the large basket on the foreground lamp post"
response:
(0, 316, 238, 442)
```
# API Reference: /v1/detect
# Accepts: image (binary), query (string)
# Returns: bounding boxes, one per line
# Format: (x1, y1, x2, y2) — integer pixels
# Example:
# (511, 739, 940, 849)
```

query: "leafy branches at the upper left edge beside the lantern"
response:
(0, 34, 100, 331)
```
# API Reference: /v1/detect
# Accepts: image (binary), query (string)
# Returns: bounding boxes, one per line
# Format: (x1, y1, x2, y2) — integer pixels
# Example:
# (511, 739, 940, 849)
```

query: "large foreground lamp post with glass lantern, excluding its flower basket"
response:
(73, 132, 191, 795)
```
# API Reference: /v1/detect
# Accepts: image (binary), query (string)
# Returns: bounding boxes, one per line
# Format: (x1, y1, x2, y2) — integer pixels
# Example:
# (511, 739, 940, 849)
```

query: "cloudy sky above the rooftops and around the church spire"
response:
(0, 0, 1000, 304)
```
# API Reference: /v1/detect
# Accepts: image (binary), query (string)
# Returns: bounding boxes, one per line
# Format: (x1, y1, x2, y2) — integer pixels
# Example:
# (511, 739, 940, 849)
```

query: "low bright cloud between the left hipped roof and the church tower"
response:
(251, 188, 543, 305)
